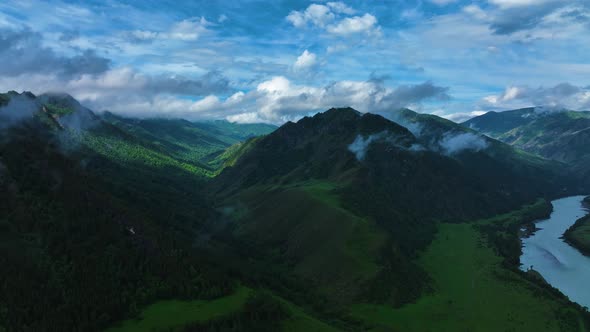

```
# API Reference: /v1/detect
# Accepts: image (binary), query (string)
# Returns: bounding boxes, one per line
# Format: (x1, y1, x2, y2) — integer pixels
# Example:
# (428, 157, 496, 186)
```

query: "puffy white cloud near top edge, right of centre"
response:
(287, 2, 381, 36)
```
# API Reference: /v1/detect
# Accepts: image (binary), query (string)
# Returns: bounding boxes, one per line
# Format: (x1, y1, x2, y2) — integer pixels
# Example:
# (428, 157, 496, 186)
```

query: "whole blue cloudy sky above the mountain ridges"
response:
(0, 0, 590, 124)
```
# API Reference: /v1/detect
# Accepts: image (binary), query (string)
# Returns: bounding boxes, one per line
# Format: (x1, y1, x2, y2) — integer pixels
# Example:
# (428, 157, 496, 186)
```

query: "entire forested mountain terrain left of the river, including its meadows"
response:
(0, 92, 589, 331)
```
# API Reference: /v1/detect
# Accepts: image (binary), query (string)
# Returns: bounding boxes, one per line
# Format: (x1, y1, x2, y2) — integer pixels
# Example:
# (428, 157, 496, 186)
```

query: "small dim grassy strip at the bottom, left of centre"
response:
(105, 287, 252, 332)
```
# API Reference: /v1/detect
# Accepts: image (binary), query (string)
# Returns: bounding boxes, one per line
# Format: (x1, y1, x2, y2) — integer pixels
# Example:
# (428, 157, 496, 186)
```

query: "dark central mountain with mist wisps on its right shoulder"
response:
(211, 108, 569, 305)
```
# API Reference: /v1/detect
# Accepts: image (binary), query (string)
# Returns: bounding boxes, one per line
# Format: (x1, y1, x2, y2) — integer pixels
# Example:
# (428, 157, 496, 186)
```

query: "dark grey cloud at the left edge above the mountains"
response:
(0, 29, 111, 79)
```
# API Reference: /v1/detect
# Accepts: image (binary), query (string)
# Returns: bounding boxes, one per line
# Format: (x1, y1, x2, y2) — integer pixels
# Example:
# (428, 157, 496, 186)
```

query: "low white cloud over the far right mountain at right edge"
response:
(482, 83, 590, 110)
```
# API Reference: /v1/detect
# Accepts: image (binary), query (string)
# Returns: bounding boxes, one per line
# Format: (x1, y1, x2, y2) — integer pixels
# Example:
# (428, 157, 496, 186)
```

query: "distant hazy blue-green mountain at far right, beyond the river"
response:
(464, 107, 590, 180)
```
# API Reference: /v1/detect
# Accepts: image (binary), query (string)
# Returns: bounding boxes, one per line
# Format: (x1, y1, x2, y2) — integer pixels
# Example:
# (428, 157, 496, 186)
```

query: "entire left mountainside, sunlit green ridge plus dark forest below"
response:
(0, 92, 286, 331)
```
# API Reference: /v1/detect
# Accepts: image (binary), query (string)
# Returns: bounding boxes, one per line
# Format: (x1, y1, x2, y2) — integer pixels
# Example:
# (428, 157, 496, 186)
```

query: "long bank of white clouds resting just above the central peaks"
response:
(23, 73, 449, 124)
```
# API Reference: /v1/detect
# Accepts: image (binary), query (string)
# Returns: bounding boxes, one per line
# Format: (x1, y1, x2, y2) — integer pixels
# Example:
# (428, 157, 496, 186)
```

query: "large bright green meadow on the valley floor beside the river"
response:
(352, 224, 584, 332)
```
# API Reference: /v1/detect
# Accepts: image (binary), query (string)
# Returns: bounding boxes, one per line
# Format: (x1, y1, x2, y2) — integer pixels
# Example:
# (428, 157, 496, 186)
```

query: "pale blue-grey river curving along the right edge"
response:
(520, 196, 590, 308)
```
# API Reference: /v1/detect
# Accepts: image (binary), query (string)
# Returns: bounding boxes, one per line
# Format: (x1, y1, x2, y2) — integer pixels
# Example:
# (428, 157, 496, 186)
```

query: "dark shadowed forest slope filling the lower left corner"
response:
(0, 123, 234, 331)
